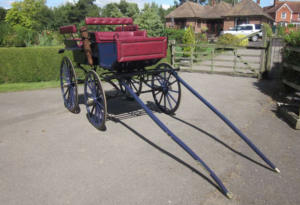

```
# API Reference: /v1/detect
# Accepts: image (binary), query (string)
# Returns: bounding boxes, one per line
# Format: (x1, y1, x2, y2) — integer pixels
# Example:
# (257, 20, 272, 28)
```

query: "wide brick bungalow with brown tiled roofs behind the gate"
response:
(165, 0, 274, 35)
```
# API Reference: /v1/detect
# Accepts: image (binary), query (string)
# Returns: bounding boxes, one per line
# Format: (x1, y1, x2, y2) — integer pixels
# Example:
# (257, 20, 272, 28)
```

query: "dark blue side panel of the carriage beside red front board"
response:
(98, 42, 117, 69)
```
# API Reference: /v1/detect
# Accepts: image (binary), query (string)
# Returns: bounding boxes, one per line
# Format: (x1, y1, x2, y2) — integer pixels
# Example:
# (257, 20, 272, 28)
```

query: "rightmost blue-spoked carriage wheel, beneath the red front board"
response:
(151, 63, 181, 114)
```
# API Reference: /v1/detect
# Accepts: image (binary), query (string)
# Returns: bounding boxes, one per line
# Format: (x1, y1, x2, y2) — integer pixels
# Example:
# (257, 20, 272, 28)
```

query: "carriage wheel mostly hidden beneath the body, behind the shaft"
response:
(119, 76, 143, 100)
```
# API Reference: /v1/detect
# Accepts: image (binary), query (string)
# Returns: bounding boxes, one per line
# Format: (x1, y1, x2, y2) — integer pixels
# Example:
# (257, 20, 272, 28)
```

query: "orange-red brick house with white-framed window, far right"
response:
(263, 0, 300, 26)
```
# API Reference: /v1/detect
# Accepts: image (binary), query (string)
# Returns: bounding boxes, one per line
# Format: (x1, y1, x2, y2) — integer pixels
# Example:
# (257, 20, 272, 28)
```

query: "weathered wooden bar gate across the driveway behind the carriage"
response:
(170, 28, 270, 78)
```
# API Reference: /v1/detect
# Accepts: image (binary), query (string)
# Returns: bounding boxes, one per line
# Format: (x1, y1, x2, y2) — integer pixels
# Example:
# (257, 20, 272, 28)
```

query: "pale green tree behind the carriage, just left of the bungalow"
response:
(134, 4, 164, 36)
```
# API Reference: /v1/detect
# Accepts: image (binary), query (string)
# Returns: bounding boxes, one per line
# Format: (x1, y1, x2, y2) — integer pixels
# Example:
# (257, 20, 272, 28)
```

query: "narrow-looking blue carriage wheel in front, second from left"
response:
(84, 70, 107, 130)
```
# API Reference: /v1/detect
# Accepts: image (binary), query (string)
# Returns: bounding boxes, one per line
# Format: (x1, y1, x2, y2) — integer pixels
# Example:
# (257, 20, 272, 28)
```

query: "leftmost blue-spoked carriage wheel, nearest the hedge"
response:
(60, 57, 79, 113)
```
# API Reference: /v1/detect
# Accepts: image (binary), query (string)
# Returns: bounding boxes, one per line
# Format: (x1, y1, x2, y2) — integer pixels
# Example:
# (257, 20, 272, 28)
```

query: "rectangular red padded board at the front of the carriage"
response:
(117, 37, 167, 62)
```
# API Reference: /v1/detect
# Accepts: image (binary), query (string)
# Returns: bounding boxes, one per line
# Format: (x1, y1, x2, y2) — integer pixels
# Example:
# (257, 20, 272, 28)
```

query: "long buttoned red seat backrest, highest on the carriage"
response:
(85, 17, 133, 25)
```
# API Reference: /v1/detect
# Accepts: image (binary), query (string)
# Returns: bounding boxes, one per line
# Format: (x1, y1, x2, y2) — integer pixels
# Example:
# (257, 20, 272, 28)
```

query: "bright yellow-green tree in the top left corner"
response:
(5, 0, 46, 29)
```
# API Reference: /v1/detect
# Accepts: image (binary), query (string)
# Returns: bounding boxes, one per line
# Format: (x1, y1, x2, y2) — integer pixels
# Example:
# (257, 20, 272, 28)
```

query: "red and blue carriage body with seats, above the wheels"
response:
(60, 18, 167, 70)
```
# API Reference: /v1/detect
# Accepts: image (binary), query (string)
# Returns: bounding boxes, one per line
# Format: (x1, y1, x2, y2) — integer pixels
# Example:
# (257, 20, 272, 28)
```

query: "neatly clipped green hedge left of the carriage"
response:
(0, 47, 73, 83)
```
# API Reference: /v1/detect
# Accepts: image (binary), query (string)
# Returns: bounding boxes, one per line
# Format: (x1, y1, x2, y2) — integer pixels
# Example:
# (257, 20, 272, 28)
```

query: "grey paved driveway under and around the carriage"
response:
(0, 73, 300, 205)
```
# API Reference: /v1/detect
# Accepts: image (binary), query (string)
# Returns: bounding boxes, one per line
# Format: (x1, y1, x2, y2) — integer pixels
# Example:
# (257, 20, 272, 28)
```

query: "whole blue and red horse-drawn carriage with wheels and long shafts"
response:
(59, 18, 279, 198)
